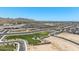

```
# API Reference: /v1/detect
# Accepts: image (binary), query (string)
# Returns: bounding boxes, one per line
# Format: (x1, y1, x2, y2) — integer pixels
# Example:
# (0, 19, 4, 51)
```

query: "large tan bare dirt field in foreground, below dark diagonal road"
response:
(28, 34, 79, 51)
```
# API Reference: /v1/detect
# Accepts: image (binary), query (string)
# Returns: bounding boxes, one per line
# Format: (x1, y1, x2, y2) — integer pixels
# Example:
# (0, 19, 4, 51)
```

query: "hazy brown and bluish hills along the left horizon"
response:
(0, 17, 34, 24)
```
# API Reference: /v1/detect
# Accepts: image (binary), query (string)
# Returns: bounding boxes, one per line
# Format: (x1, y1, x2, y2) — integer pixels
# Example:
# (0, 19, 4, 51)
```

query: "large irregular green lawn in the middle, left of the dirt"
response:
(6, 32, 48, 45)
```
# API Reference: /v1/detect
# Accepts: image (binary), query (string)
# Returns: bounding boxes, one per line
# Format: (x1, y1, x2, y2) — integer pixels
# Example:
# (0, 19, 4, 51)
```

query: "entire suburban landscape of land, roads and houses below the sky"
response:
(0, 18, 79, 51)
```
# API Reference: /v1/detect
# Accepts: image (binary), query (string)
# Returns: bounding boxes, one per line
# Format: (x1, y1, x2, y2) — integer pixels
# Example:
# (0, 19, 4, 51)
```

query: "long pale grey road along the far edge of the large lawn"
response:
(0, 30, 60, 35)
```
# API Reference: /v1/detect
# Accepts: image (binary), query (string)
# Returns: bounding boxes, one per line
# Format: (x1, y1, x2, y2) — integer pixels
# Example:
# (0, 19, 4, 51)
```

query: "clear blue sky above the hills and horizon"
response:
(0, 7, 79, 21)
